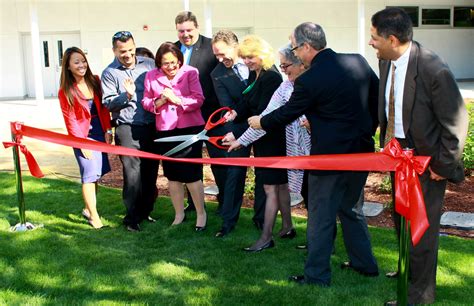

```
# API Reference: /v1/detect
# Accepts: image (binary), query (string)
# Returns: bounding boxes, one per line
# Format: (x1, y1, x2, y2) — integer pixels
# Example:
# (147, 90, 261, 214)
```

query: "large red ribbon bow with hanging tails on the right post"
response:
(383, 138, 431, 245)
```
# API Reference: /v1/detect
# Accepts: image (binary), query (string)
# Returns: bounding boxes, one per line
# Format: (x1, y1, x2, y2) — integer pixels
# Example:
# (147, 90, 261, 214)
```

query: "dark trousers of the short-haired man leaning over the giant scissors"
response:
(221, 147, 266, 230)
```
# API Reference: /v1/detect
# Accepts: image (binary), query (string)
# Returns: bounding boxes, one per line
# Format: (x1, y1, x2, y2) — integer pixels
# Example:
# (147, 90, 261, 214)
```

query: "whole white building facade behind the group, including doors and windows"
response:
(0, 0, 474, 101)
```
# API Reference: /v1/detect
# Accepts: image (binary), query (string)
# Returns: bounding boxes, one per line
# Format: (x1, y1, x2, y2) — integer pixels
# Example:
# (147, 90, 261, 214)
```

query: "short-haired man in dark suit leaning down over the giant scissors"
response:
(211, 30, 266, 237)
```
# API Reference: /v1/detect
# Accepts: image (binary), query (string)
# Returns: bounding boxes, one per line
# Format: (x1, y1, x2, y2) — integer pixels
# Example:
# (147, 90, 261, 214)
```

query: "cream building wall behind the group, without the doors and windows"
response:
(0, 0, 474, 99)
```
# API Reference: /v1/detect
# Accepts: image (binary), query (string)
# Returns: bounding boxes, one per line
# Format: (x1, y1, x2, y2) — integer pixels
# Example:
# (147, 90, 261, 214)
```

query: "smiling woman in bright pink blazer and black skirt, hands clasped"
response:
(142, 42, 207, 232)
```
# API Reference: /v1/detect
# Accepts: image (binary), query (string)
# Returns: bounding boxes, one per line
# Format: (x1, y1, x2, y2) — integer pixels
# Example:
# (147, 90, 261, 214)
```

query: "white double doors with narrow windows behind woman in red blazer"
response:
(22, 33, 81, 97)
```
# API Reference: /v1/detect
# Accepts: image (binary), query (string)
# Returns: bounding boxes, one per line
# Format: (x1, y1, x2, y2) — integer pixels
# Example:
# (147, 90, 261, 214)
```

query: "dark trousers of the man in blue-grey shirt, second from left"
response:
(115, 124, 159, 225)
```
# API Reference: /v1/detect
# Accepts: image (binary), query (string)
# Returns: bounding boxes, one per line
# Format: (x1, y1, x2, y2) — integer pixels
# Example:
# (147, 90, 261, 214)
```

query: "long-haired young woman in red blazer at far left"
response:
(58, 47, 112, 229)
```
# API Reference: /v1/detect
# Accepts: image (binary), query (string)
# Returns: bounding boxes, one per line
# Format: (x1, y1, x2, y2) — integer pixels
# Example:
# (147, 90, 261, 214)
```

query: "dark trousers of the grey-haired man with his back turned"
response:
(304, 171, 378, 285)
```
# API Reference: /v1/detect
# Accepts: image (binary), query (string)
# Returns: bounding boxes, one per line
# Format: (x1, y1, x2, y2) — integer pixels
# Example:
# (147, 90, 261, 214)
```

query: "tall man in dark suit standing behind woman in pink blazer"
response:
(175, 11, 226, 211)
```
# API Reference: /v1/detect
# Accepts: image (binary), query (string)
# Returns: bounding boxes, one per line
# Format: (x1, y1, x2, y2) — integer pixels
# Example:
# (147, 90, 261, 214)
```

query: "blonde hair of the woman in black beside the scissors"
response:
(239, 35, 275, 70)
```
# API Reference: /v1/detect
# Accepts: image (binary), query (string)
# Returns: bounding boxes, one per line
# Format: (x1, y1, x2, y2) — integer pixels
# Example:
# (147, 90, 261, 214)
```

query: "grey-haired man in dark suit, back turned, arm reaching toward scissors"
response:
(251, 22, 378, 286)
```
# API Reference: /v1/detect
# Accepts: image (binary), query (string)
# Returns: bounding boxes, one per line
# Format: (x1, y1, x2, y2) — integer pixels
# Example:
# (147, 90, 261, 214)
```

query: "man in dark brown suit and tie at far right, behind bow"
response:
(369, 8, 468, 305)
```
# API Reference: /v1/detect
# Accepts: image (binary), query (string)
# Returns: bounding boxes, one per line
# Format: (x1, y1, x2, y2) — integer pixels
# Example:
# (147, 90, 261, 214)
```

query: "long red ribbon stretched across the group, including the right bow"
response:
(6, 124, 430, 245)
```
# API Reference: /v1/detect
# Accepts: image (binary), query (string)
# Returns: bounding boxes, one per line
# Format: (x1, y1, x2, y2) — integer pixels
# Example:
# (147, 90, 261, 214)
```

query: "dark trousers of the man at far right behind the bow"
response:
(391, 170, 447, 304)
